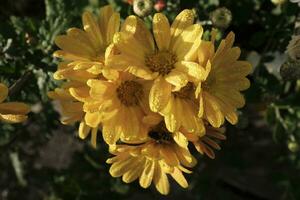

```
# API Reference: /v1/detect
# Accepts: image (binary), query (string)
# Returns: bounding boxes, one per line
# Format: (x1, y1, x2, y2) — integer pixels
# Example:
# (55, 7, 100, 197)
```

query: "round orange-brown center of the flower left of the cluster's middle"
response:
(117, 81, 143, 106)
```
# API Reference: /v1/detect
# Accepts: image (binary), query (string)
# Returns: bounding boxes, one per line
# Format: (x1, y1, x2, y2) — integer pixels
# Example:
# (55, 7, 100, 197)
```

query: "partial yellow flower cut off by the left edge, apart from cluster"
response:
(0, 83, 30, 123)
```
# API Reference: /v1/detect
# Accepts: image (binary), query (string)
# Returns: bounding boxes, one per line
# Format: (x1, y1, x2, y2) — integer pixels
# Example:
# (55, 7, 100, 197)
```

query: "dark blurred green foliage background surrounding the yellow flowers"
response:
(0, 0, 300, 200)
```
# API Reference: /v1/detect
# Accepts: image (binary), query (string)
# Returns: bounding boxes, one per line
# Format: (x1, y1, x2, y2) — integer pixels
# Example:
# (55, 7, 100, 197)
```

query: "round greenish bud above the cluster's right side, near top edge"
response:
(210, 7, 232, 29)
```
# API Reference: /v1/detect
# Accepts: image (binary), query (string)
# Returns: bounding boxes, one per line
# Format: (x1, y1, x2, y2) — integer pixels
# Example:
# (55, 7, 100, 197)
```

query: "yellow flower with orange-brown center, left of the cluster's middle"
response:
(79, 73, 150, 144)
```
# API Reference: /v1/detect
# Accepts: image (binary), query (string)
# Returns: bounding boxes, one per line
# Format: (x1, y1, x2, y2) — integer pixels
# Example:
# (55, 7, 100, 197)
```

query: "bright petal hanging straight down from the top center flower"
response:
(149, 76, 171, 112)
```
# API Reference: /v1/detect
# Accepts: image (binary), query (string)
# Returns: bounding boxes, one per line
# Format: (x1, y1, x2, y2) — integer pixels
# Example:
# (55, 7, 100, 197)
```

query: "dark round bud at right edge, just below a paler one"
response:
(280, 61, 300, 81)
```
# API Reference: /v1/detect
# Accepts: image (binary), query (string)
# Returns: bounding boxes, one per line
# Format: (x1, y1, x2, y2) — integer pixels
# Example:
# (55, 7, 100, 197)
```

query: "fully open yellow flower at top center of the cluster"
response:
(106, 10, 203, 128)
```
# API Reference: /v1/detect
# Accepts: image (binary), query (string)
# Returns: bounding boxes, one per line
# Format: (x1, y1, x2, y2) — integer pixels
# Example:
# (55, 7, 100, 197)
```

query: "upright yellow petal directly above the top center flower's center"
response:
(153, 13, 171, 50)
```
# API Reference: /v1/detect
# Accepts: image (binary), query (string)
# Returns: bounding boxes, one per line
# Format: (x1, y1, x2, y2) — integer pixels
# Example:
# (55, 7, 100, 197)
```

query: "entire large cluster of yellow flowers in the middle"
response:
(49, 6, 251, 194)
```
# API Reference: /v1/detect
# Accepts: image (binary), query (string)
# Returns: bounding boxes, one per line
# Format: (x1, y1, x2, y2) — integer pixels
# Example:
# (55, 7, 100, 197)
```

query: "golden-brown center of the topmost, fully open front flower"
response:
(145, 51, 176, 75)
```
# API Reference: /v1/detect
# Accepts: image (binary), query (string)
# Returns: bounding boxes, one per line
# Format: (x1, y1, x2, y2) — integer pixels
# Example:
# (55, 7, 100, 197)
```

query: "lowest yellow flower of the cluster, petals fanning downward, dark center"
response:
(107, 118, 196, 194)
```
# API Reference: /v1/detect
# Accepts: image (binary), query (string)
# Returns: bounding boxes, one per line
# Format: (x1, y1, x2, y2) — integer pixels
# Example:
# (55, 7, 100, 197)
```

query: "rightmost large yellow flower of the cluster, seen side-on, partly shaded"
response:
(197, 32, 251, 127)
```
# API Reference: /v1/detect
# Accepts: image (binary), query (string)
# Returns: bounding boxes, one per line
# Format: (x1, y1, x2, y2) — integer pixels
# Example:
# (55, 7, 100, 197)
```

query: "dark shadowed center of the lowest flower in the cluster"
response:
(148, 121, 173, 143)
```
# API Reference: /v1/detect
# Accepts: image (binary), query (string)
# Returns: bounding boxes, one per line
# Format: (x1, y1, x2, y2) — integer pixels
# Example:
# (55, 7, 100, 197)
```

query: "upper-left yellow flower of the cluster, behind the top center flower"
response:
(54, 6, 120, 74)
